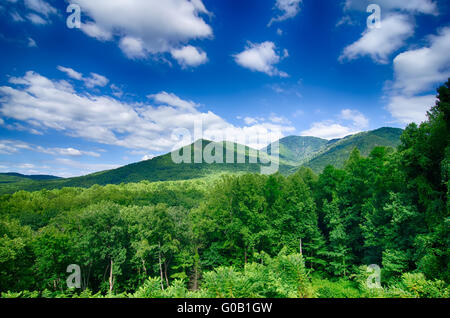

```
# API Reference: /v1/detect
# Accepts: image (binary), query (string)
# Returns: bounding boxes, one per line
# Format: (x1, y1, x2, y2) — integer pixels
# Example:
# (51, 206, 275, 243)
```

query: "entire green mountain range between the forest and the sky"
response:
(0, 128, 402, 193)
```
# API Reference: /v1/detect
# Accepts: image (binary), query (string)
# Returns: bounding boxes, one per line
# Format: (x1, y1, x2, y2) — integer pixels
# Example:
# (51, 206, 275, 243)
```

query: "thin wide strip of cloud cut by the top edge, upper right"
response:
(345, 0, 438, 14)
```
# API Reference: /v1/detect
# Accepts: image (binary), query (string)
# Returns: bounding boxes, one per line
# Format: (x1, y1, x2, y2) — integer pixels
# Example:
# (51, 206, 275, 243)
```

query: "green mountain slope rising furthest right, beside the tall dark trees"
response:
(305, 127, 403, 173)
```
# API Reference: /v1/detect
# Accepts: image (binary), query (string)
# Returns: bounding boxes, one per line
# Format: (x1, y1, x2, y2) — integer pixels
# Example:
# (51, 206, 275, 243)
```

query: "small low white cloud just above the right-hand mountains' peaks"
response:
(301, 109, 369, 139)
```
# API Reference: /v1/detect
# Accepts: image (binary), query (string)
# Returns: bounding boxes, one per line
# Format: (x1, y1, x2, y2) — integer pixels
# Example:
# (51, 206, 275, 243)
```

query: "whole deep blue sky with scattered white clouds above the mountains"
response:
(0, 0, 450, 177)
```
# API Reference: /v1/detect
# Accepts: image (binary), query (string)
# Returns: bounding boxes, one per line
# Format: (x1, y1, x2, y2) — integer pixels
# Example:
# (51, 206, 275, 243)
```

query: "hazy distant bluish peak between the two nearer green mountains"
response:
(263, 136, 328, 166)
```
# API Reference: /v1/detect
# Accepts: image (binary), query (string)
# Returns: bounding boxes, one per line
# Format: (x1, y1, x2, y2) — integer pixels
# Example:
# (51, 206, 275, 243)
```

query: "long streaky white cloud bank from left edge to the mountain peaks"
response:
(0, 71, 295, 152)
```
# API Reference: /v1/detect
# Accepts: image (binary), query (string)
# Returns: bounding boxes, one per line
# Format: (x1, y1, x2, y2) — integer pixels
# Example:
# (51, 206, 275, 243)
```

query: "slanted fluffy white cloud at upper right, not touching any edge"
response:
(339, 14, 414, 63)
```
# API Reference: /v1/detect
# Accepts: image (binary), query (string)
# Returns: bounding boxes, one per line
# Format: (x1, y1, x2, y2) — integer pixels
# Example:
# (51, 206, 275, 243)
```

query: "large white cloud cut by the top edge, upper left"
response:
(72, 0, 213, 59)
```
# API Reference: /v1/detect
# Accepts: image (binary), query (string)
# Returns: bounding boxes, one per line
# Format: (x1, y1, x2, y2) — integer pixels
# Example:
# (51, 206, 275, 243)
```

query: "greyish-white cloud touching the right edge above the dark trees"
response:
(393, 28, 450, 95)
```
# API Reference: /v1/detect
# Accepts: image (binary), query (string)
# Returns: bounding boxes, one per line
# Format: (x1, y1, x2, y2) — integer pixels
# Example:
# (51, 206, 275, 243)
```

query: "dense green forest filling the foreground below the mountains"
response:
(0, 81, 450, 297)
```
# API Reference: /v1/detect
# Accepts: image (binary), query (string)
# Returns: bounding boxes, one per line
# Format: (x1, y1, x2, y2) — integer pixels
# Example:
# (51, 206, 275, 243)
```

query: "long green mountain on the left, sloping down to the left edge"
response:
(0, 140, 294, 194)
